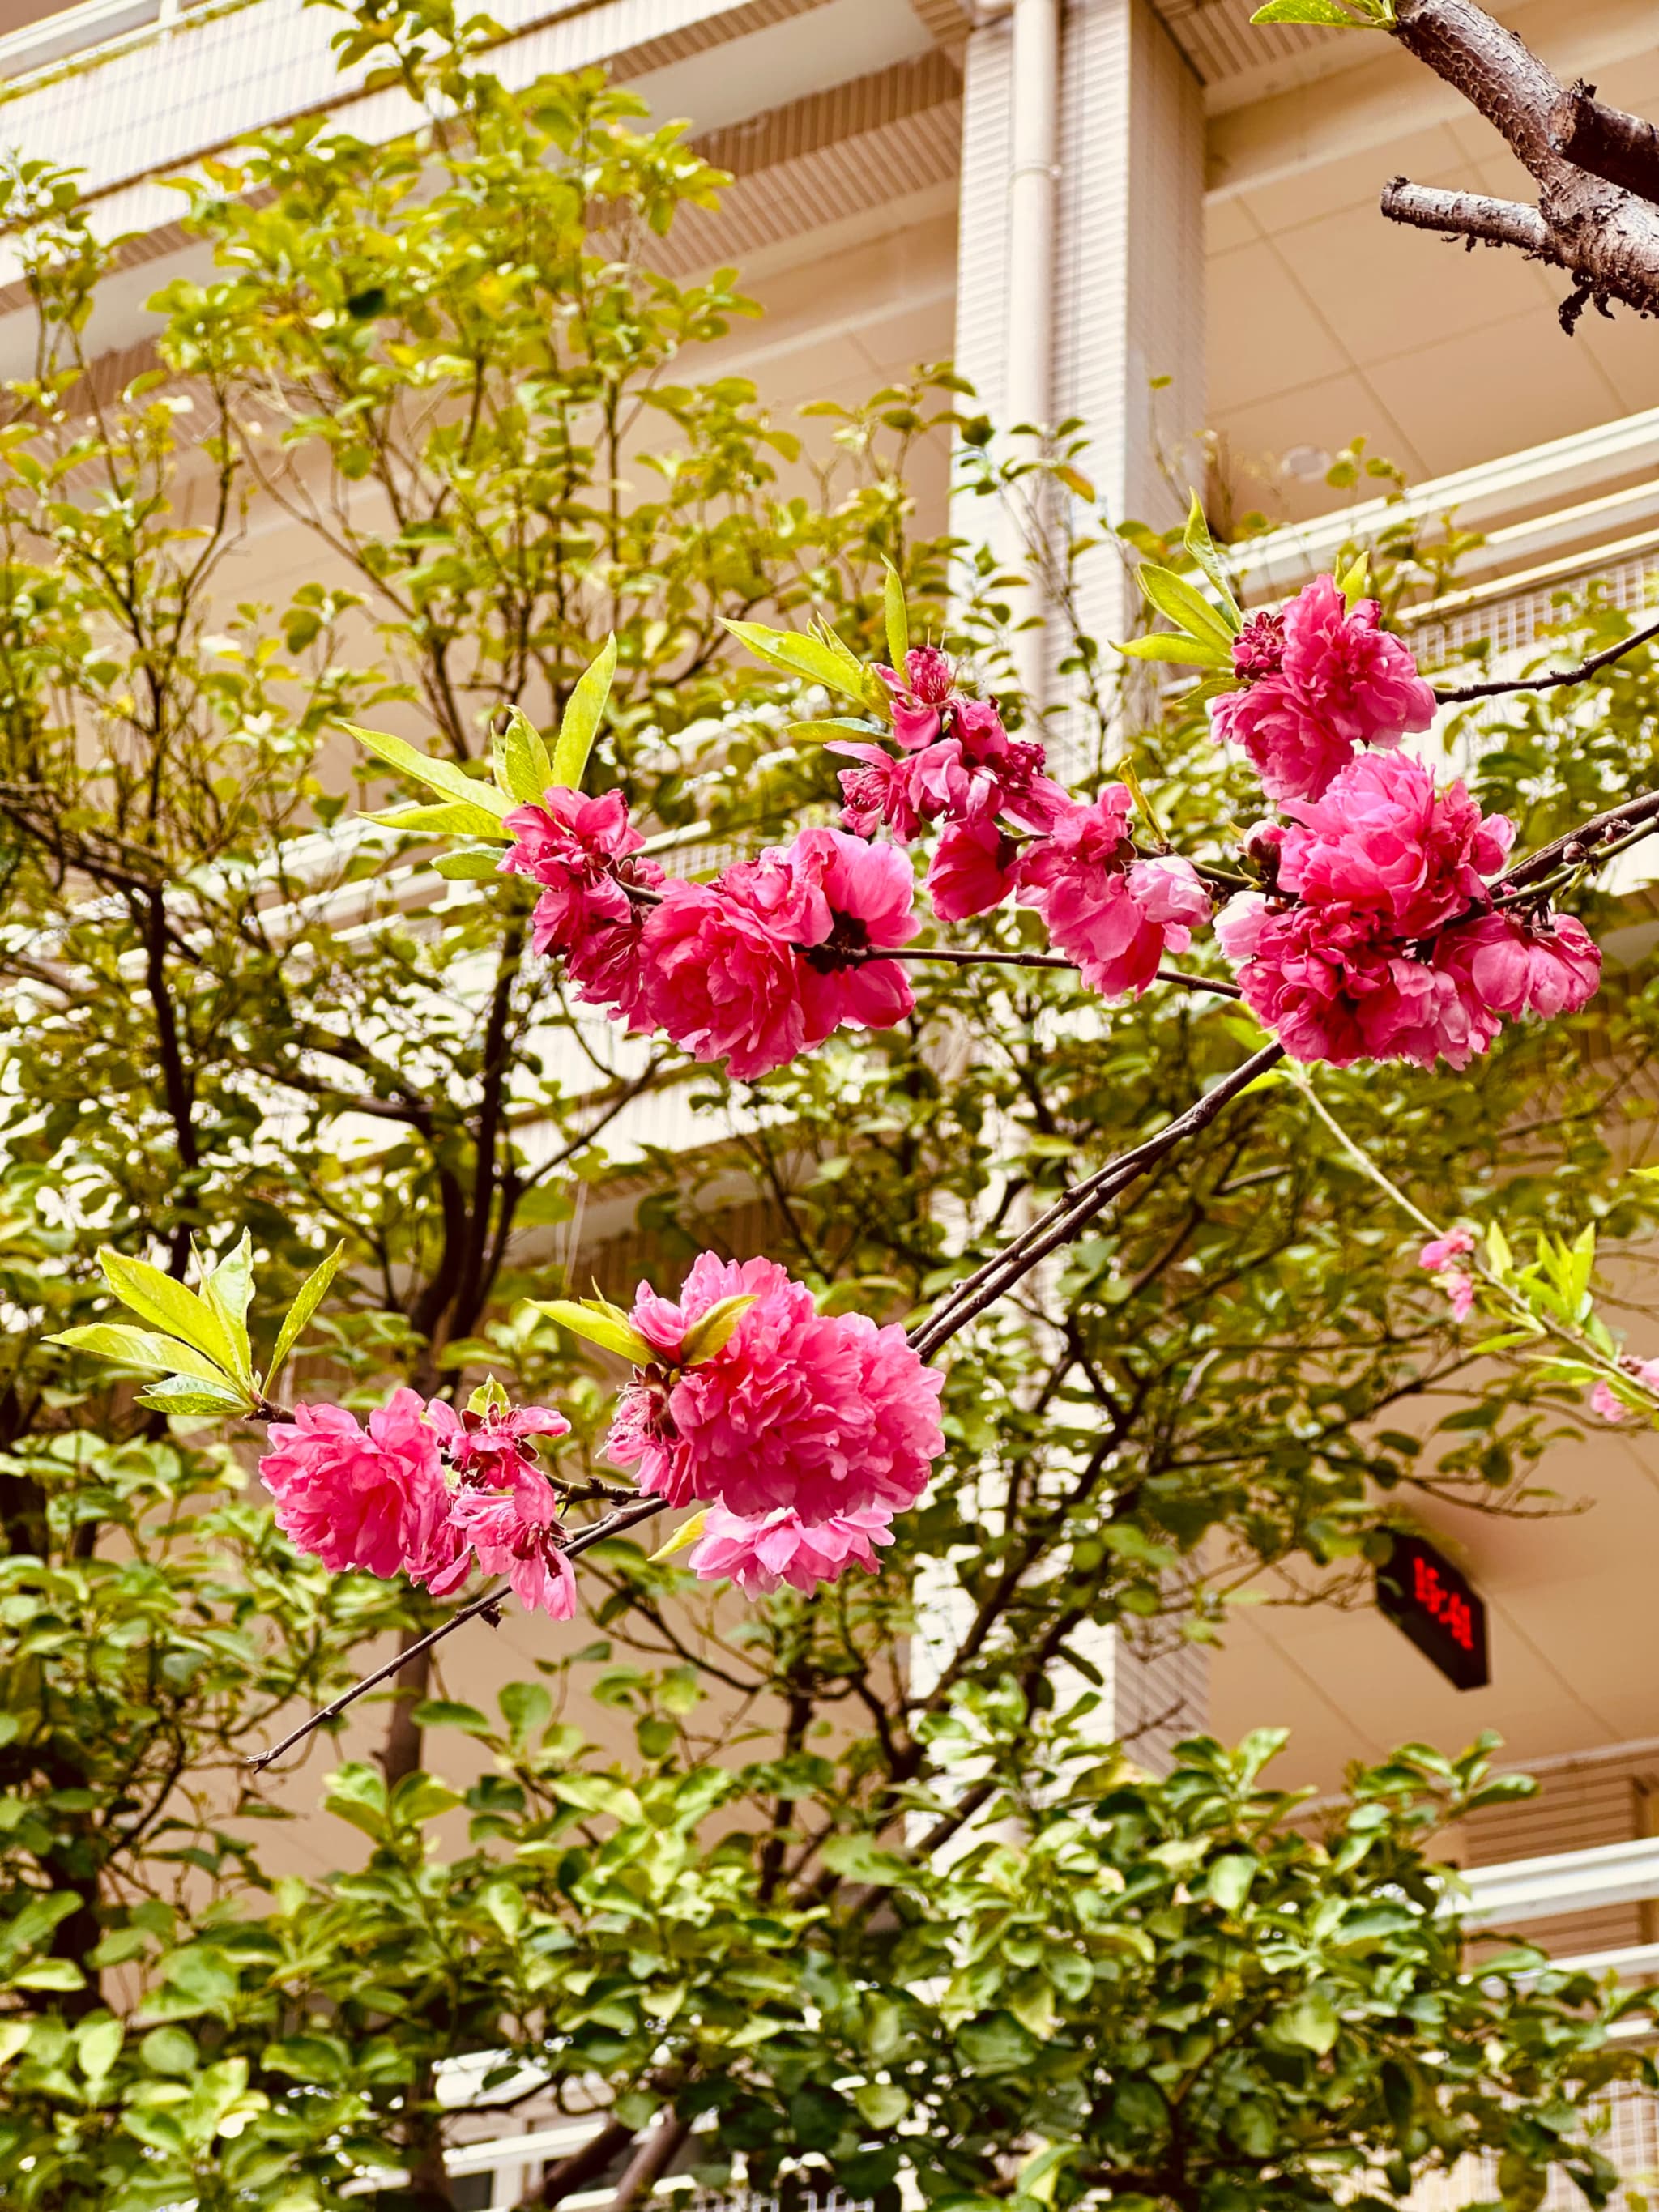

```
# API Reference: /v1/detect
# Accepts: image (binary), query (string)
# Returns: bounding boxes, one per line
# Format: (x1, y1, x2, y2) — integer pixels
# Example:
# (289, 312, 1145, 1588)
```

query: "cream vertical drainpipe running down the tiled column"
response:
(1002, 0, 1062, 710)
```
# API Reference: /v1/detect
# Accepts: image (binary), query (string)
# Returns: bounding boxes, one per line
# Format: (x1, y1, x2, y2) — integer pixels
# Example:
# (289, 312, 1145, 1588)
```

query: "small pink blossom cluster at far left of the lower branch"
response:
(258, 1389, 575, 1622)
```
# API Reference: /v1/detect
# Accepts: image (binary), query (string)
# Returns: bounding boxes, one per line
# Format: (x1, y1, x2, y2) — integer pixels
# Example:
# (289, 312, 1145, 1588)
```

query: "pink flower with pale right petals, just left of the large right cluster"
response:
(1017, 783, 1210, 998)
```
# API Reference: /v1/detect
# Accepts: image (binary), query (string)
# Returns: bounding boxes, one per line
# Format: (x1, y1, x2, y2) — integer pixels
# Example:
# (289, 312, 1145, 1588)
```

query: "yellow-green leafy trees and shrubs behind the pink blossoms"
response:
(0, 0, 1659, 2212)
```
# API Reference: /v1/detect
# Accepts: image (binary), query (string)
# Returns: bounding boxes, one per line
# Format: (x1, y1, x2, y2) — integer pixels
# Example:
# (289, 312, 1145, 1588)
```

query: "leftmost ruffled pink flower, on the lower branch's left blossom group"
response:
(258, 1389, 458, 1582)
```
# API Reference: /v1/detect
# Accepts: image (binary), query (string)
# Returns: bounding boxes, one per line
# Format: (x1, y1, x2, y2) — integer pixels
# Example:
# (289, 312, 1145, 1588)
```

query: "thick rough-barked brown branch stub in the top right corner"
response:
(1383, 0, 1659, 332)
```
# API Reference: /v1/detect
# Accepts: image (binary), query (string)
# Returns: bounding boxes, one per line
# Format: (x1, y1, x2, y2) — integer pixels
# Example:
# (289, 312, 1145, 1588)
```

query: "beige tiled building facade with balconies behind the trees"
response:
(0, 0, 1659, 2208)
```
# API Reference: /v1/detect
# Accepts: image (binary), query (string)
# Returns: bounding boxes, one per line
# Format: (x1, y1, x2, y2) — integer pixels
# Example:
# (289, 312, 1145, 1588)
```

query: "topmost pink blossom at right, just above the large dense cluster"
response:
(1210, 575, 1435, 803)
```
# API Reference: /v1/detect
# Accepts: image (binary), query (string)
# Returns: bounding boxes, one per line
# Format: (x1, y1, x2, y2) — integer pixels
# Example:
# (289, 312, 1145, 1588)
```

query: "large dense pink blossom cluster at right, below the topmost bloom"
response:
(1217, 752, 1601, 1068)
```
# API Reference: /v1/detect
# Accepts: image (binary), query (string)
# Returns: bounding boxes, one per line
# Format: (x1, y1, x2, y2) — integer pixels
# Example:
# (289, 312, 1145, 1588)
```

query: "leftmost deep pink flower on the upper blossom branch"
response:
(502, 786, 663, 1017)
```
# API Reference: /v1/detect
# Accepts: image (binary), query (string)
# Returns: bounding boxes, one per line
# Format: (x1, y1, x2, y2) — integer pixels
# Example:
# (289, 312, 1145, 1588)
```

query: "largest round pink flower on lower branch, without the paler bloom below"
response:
(606, 1252, 945, 1524)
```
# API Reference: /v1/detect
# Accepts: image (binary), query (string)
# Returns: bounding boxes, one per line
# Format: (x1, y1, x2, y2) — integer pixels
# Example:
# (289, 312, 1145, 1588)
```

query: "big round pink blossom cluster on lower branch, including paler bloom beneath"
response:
(606, 1252, 945, 1588)
